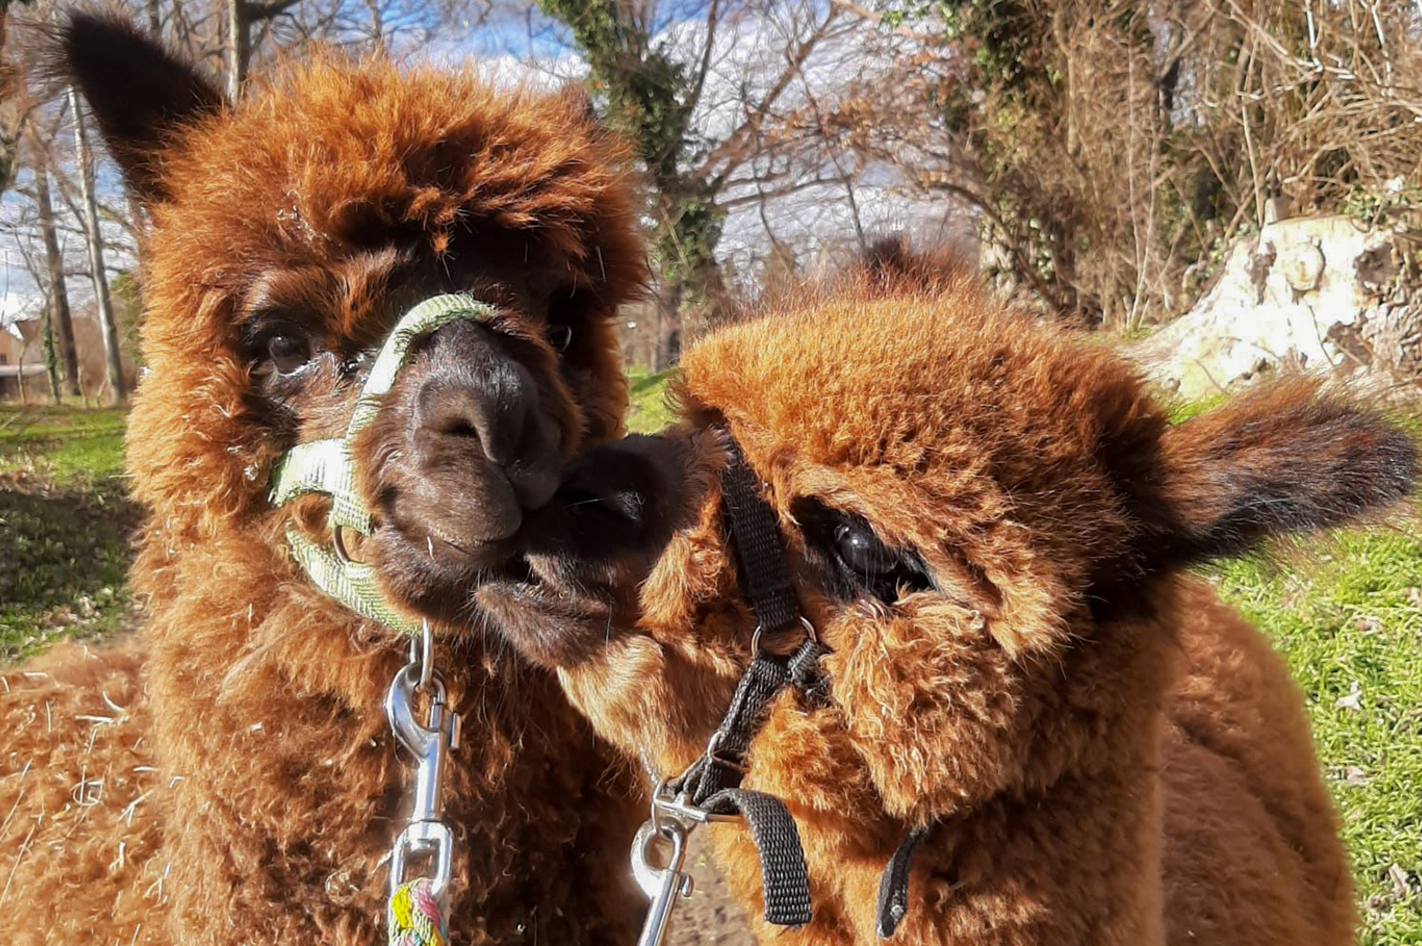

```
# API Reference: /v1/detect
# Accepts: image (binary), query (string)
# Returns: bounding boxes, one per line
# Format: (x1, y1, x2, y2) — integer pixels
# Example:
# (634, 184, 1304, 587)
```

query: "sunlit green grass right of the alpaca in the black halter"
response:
(1209, 531, 1422, 946)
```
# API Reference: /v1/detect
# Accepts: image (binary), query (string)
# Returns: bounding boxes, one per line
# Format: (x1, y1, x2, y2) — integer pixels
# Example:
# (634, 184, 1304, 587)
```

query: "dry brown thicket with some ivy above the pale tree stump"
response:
(864, 0, 1422, 331)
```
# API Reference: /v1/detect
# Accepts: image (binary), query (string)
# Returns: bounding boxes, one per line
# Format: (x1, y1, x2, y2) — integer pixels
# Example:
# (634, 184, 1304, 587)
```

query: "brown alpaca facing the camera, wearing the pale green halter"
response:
(0, 16, 644, 946)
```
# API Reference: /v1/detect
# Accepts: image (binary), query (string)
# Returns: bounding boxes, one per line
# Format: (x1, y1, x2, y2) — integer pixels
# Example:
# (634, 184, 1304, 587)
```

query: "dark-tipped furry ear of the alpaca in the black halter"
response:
(1139, 378, 1418, 568)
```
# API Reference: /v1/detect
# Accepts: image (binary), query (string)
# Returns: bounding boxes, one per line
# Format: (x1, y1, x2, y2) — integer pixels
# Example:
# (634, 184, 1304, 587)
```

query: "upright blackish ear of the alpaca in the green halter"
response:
(50, 13, 226, 202)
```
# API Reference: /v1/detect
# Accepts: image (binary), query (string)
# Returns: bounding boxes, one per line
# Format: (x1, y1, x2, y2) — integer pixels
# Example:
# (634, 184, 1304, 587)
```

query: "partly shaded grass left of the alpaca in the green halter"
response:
(0, 405, 137, 659)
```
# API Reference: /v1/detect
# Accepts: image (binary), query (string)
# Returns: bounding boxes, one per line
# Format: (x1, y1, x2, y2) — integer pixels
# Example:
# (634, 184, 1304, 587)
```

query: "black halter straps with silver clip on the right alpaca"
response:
(631, 438, 825, 946)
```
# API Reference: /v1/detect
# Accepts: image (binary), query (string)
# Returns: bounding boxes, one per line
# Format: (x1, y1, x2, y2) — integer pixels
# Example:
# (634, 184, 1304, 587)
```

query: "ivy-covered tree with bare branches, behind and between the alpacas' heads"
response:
(538, 0, 841, 368)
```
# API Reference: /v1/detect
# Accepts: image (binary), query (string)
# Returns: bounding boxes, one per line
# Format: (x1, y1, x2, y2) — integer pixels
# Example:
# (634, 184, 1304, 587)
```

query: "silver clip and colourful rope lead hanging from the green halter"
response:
(385, 622, 459, 946)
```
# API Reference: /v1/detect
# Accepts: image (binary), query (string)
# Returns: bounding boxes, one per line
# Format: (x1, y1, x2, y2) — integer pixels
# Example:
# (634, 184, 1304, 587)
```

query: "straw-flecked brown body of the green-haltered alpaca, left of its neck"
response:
(0, 640, 162, 946)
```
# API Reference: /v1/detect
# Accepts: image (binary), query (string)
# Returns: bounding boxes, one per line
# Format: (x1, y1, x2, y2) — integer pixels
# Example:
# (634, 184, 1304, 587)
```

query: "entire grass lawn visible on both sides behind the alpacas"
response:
(0, 384, 1422, 946)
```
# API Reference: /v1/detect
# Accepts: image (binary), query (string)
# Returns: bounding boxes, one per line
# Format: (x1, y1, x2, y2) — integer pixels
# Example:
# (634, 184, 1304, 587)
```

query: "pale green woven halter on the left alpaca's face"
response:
(272, 294, 493, 633)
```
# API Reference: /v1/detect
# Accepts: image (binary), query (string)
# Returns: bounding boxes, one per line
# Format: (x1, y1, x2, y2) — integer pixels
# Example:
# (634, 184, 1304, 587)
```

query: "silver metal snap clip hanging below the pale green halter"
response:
(385, 661, 459, 900)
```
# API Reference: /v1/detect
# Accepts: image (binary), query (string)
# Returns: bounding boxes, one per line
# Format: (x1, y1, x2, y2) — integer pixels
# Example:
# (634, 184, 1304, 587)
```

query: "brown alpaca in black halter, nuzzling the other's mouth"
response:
(478, 266, 1415, 946)
